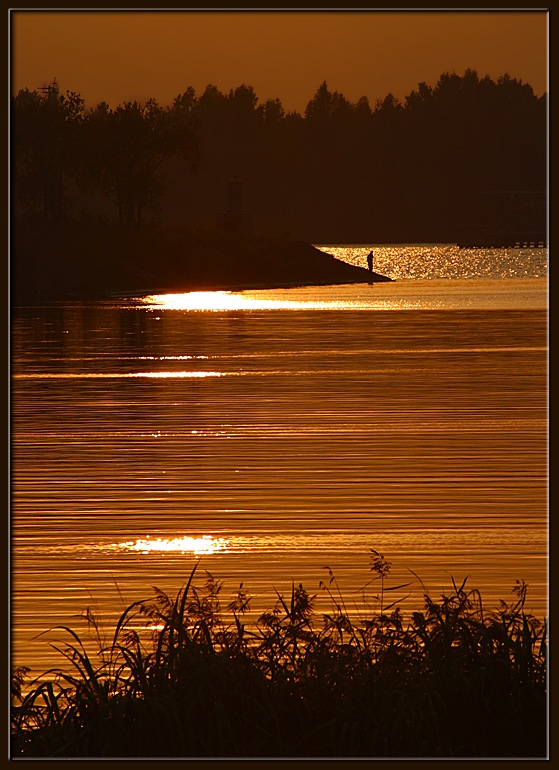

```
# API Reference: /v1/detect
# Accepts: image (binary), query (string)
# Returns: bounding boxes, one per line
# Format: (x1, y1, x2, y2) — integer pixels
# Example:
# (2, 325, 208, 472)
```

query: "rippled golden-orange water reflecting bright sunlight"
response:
(11, 246, 547, 673)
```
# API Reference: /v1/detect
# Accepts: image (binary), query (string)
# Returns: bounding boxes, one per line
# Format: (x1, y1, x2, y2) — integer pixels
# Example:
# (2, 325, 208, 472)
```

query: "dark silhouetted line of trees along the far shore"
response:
(12, 69, 547, 243)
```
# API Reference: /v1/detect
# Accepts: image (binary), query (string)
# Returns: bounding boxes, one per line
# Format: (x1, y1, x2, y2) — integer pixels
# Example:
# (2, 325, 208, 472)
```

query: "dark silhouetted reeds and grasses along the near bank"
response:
(12, 551, 547, 758)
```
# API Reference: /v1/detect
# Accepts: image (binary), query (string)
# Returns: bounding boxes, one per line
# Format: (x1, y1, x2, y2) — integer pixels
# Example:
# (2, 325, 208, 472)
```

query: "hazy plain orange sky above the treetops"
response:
(11, 10, 549, 113)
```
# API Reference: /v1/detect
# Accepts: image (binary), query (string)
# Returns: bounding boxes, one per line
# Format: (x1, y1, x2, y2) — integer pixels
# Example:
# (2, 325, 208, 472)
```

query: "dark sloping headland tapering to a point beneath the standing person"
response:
(11, 222, 391, 304)
